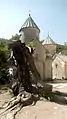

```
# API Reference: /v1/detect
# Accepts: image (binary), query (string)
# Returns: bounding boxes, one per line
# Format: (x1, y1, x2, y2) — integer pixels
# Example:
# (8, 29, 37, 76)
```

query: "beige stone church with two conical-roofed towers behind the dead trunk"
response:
(19, 14, 56, 81)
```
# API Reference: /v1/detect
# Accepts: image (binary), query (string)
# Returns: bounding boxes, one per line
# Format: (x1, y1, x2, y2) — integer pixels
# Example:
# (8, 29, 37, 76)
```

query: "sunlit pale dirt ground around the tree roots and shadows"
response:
(0, 83, 67, 119)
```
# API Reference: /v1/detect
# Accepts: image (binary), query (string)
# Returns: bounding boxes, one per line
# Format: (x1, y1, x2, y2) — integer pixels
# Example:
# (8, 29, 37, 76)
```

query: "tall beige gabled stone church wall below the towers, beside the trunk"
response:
(34, 41, 52, 81)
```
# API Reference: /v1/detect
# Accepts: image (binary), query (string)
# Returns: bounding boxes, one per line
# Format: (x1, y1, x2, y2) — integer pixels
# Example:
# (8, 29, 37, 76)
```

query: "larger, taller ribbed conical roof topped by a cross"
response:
(19, 14, 40, 32)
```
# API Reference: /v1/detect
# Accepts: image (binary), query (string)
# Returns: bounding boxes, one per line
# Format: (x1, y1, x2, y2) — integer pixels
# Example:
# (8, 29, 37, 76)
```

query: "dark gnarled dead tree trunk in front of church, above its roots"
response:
(12, 41, 40, 95)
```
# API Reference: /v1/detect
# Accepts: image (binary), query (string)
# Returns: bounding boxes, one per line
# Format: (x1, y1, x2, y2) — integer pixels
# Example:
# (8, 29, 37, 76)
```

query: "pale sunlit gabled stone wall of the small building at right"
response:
(52, 57, 66, 79)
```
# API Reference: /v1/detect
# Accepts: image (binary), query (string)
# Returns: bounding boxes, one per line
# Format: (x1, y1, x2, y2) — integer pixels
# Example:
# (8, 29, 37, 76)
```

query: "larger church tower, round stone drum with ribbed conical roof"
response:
(19, 14, 40, 44)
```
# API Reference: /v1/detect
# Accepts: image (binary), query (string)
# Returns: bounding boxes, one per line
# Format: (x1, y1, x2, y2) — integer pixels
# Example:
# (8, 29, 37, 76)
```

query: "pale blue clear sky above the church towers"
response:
(0, 0, 67, 44)
